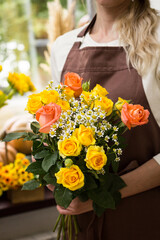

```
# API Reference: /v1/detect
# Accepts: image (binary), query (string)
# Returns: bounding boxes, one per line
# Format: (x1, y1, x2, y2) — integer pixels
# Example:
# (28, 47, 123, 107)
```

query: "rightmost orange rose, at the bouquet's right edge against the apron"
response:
(121, 103, 150, 129)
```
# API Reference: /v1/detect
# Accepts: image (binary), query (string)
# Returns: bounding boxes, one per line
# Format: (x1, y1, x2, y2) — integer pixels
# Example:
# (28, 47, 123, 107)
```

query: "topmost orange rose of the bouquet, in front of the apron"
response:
(64, 72, 83, 97)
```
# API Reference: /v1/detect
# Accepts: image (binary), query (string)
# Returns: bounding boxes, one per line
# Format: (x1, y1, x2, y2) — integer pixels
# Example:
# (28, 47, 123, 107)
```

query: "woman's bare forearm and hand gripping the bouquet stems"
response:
(57, 159, 160, 215)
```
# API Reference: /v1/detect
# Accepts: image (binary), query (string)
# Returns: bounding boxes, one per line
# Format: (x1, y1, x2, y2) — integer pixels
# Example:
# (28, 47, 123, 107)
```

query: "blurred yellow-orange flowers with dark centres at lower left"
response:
(0, 153, 34, 196)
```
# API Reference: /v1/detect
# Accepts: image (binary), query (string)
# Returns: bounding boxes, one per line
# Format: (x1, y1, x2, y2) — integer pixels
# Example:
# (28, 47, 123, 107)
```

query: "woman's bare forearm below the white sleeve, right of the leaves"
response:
(120, 159, 160, 198)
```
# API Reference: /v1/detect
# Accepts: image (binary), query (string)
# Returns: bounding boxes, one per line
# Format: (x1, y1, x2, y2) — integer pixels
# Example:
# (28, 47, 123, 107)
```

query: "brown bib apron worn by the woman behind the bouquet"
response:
(61, 18, 160, 240)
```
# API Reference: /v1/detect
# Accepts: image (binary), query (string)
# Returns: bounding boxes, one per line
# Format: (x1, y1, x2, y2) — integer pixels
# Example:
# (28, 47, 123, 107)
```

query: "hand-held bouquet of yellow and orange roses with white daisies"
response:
(4, 73, 149, 240)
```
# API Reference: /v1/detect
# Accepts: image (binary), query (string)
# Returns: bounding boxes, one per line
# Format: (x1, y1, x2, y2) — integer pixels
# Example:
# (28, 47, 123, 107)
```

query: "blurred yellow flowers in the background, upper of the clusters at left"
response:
(0, 65, 36, 108)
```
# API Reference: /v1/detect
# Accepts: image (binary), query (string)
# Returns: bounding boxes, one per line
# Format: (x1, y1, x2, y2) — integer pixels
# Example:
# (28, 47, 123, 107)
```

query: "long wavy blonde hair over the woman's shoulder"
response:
(116, 0, 160, 79)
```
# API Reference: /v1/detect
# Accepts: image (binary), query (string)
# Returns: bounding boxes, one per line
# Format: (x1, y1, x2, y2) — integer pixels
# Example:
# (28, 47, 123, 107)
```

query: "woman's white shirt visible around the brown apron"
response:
(51, 26, 160, 164)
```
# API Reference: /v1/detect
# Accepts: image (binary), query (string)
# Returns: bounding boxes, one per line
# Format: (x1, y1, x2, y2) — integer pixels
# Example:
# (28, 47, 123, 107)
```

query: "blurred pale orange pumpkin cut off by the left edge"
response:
(0, 142, 17, 164)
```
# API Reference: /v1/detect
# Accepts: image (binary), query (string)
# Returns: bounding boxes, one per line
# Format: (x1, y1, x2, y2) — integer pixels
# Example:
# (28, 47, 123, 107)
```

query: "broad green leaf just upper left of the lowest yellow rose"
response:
(42, 152, 58, 172)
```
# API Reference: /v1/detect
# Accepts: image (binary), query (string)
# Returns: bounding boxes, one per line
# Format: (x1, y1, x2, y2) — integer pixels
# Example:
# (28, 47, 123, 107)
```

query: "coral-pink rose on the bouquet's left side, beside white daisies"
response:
(36, 103, 61, 133)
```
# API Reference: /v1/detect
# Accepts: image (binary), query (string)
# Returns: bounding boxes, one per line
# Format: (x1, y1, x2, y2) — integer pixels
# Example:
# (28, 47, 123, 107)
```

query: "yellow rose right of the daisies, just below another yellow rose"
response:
(94, 97, 113, 116)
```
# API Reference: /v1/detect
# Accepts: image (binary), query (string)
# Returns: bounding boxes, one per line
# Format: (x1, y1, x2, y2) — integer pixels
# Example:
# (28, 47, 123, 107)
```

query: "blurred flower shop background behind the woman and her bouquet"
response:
(0, 0, 160, 240)
